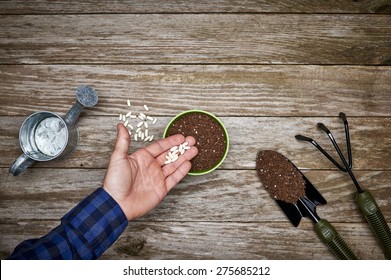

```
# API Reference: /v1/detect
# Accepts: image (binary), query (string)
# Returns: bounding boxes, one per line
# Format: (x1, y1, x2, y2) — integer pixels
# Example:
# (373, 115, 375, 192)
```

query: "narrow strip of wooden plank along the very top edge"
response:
(0, 0, 390, 14)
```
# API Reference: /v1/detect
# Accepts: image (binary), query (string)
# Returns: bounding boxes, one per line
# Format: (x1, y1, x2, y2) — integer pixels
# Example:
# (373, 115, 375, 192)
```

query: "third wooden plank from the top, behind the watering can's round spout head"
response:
(0, 65, 391, 117)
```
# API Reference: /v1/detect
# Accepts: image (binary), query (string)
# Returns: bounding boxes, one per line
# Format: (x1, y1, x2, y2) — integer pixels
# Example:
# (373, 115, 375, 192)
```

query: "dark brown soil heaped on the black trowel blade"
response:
(256, 151, 305, 203)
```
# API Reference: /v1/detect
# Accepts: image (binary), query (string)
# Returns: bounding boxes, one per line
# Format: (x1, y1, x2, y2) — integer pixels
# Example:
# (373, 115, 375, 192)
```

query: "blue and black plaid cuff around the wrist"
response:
(62, 188, 128, 259)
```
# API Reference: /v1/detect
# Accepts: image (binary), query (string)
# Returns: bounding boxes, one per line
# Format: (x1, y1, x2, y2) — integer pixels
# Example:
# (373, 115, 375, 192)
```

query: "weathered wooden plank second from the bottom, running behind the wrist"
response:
(0, 168, 391, 223)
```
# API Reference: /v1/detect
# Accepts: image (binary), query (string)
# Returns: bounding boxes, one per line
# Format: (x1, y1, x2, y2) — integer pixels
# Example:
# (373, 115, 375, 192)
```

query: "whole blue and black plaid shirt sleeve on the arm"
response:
(8, 188, 128, 260)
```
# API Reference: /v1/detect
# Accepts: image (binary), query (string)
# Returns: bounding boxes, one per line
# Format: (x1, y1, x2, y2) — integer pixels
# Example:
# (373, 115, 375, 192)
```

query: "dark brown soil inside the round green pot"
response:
(167, 112, 227, 172)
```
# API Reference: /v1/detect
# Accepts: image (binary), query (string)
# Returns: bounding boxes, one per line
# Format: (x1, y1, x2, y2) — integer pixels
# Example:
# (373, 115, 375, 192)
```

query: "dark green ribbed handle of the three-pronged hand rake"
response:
(356, 191, 391, 260)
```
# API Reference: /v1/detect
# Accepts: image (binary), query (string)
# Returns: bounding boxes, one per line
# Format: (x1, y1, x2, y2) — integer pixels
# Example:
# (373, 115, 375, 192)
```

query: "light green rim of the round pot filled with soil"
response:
(163, 110, 229, 175)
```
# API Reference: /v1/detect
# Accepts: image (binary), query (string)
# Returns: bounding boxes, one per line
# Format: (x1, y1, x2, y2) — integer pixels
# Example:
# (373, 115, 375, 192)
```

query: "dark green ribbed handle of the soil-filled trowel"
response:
(315, 219, 357, 260)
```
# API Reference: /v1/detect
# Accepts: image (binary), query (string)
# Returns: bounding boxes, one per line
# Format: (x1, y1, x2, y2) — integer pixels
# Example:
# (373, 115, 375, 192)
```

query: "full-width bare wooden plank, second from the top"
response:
(0, 14, 391, 65)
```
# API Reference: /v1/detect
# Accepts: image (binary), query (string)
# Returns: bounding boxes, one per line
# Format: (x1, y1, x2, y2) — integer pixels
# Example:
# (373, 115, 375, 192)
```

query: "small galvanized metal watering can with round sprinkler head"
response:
(9, 86, 98, 176)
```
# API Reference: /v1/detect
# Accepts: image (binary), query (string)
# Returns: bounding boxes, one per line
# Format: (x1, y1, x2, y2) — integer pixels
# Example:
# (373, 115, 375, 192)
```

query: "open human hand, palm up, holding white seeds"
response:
(103, 124, 198, 221)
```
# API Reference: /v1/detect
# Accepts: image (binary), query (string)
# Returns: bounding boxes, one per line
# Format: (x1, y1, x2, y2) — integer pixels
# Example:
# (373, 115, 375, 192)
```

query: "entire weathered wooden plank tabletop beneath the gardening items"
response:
(0, 0, 391, 259)
